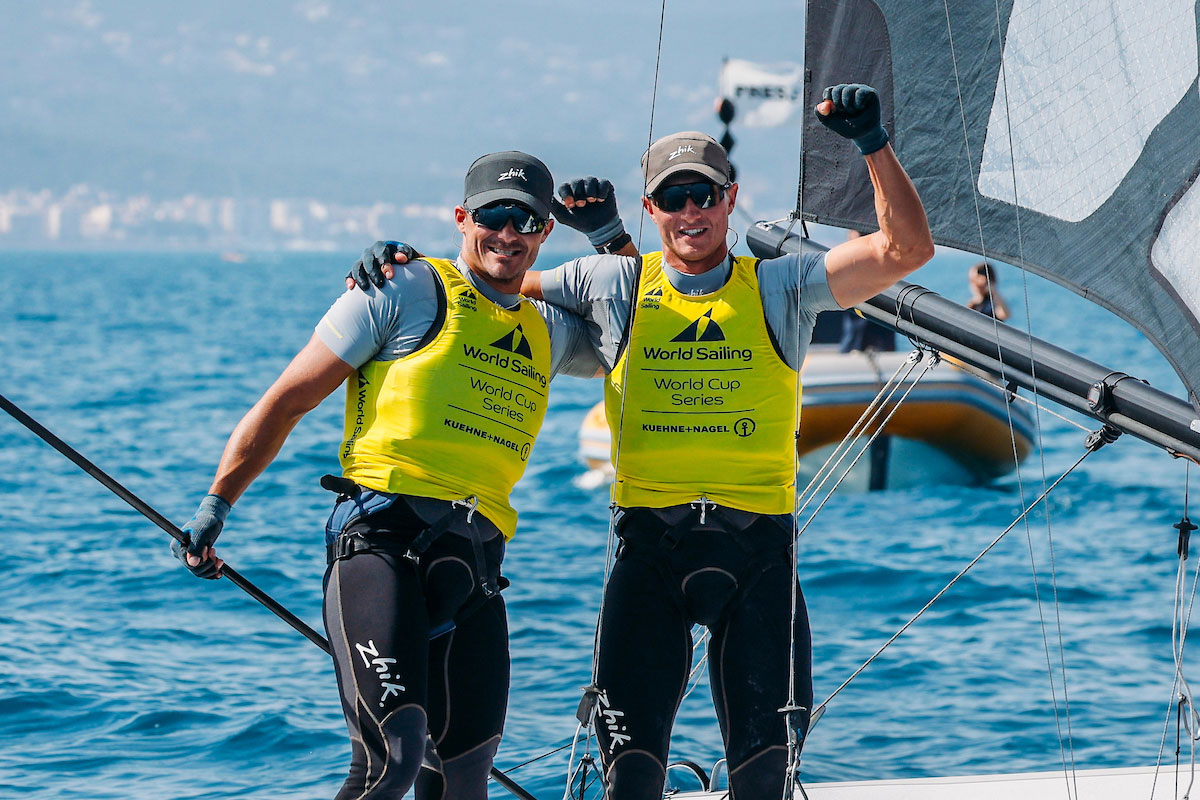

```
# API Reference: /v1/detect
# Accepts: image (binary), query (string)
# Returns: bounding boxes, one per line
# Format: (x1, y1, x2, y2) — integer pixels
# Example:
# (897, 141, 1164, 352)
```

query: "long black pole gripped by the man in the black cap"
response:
(0, 395, 534, 800)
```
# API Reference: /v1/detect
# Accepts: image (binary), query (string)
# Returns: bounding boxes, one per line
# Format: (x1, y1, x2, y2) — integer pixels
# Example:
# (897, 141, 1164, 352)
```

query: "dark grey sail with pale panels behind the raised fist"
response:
(802, 0, 1200, 408)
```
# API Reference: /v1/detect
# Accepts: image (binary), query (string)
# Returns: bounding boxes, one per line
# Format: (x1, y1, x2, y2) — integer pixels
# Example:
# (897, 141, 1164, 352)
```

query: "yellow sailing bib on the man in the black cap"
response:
(340, 258, 550, 539)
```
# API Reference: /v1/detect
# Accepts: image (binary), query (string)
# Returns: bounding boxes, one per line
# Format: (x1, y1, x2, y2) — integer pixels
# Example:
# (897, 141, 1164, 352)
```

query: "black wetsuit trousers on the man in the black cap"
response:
(324, 498, 509, 800)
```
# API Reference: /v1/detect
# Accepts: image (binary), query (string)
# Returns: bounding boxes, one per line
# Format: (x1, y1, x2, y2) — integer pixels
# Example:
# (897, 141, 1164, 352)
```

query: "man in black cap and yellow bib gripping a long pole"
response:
(176, 151, 599, 800)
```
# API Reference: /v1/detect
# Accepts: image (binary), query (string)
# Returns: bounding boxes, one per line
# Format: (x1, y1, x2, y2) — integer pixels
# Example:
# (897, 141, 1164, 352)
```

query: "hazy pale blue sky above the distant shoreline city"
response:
(0, 0, 803, 224)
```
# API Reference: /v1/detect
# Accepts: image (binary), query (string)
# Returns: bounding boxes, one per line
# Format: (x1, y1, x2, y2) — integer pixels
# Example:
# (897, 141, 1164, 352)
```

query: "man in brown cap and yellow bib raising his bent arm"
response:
(352, 84, 934, 800)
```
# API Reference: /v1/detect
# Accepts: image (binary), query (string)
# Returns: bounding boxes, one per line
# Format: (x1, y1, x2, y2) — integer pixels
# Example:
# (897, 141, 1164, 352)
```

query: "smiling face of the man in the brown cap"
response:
(642, 173, 738, 275)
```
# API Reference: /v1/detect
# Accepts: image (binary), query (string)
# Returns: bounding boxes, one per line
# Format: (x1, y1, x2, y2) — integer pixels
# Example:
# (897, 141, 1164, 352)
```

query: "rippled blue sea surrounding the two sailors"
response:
(0, 249, 1200, 800)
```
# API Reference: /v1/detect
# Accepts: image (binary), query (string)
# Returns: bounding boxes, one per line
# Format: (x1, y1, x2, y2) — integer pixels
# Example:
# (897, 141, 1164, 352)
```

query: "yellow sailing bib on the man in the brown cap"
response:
(605, 253, 799, 513)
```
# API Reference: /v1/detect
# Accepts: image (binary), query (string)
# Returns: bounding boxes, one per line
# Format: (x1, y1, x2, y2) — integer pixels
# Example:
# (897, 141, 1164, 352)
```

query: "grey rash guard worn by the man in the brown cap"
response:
(541, 253, 841, 372)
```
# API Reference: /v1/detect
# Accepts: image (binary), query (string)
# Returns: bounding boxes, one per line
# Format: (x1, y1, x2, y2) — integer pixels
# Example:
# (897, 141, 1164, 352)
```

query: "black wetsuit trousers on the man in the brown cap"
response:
(596, 509, 812, 800)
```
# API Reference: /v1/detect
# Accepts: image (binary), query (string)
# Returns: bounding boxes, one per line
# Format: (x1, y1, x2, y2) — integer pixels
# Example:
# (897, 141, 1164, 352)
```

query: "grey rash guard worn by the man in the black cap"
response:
(316, 259, 600, 378)
